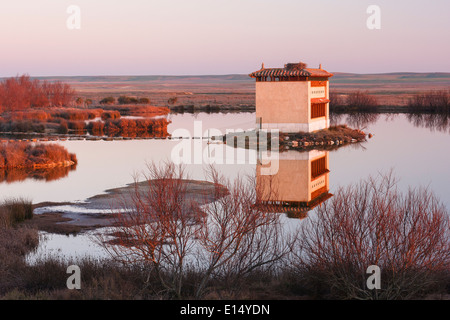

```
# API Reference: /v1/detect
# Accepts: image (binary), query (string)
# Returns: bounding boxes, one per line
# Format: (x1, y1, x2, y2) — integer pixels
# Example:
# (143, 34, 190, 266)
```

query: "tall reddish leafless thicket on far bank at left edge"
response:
(0, 75, 75, 112)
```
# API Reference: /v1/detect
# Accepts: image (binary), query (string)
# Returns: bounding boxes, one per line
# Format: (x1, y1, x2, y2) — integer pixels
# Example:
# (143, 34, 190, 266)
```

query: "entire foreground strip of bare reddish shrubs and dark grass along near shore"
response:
(0, 167, 450, 299)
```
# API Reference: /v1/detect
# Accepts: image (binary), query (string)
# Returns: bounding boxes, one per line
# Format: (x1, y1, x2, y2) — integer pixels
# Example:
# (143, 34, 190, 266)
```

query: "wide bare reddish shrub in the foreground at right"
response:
(296, 174, 450, 299)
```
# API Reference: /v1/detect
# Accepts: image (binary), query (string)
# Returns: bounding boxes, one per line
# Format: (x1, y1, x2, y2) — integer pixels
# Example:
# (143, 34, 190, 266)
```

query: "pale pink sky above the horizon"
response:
(0, 0, 450, 77)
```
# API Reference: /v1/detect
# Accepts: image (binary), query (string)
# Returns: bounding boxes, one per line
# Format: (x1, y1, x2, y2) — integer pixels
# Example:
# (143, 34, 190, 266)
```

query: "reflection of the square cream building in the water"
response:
(256, 150, 332, 218)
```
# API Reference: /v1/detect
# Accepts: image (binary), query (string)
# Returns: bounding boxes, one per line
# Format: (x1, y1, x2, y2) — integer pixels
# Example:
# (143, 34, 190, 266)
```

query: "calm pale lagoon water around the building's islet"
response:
(11, 113, 450, 261)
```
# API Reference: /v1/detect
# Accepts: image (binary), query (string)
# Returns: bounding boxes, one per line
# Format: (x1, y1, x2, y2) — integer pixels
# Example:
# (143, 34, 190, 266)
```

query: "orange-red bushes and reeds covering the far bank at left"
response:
(0, 75, 170, 137)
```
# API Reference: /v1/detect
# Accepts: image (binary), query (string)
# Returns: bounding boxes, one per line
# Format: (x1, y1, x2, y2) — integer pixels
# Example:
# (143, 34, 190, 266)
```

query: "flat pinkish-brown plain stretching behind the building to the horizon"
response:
(18, 72, 450, 110)
